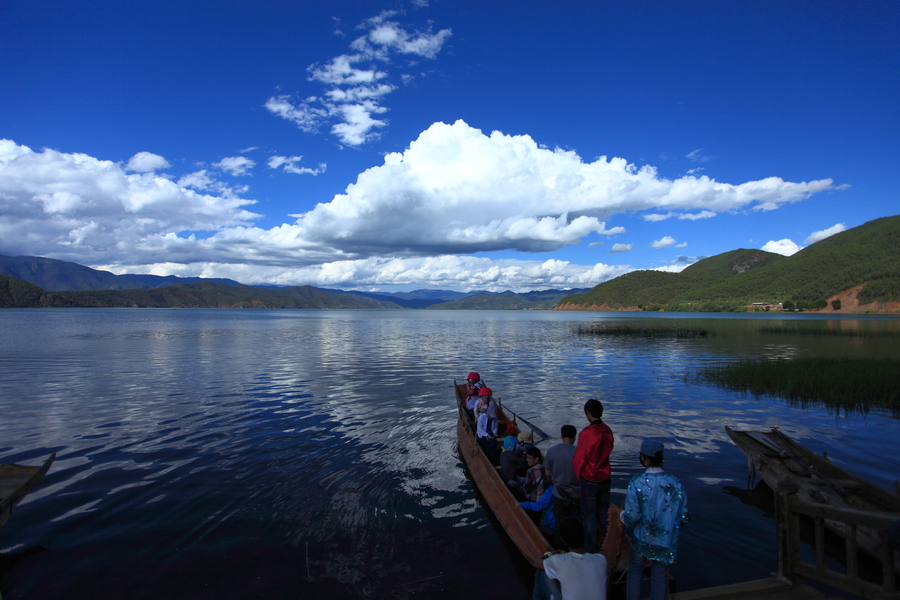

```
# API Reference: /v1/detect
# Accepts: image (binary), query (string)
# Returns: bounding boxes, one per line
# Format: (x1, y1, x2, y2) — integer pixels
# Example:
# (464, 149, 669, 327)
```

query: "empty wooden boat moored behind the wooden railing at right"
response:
(725, 425, 900, 566)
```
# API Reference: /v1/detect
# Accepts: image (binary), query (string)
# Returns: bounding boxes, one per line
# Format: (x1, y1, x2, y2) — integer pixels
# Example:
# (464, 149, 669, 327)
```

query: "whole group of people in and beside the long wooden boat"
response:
(465, 372, 688, 600)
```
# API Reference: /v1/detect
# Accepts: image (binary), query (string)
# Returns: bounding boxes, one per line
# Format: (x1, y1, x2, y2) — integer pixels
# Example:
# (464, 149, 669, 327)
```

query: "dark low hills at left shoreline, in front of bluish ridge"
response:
(0, 275, 400, 308)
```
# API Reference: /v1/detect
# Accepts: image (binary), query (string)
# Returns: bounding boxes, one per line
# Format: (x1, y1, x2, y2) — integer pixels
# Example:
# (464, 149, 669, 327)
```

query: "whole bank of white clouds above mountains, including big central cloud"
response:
(0, 121, 831, 287)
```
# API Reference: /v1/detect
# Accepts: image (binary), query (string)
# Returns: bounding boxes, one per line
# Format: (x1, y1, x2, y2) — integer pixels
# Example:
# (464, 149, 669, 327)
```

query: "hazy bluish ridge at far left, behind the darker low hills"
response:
(0, 254, 240, 291)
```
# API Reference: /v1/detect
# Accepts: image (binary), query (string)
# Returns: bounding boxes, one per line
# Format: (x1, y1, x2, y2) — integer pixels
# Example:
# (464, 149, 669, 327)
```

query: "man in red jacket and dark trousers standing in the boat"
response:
(572, 398, 613, 552)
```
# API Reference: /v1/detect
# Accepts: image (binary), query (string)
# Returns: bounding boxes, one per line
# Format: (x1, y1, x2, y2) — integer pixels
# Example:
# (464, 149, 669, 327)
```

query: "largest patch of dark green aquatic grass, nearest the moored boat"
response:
(684, 358, 900, 419)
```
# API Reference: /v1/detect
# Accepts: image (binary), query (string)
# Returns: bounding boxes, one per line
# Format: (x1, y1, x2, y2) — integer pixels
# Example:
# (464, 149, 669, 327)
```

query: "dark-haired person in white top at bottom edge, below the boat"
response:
(531, 519, 607, 600)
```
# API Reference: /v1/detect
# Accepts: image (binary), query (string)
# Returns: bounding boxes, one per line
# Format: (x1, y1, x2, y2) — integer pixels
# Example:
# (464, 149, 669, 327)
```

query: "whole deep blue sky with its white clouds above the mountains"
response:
(0, 0, 900, 291)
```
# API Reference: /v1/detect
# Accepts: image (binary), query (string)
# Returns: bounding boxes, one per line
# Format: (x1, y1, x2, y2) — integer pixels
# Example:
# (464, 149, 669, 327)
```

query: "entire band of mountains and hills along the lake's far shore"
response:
(0, 216, 900, 312)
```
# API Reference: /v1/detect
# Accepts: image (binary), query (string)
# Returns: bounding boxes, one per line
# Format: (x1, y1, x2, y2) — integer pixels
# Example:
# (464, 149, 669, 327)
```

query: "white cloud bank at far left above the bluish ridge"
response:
(0, 140, 259, 264)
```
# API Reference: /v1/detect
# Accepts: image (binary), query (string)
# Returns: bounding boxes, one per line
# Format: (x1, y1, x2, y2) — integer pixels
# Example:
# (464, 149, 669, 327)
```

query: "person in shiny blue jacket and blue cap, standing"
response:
(619, 439, 688, 600)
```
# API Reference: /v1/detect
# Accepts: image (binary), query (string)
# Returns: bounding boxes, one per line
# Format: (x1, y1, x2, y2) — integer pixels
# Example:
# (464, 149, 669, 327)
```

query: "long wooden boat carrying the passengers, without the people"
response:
(454, 384, 631, 580)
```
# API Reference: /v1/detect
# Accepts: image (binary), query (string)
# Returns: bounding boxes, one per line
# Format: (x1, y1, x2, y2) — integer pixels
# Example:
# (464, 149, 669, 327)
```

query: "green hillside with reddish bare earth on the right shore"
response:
(557, 216, 900, 311)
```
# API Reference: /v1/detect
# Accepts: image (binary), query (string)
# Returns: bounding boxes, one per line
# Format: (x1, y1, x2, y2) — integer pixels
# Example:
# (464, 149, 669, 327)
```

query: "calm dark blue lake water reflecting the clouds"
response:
(0, 309, 900, 600)
